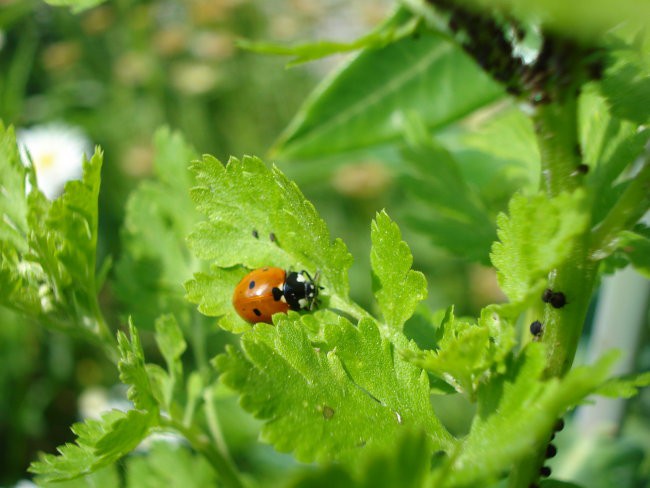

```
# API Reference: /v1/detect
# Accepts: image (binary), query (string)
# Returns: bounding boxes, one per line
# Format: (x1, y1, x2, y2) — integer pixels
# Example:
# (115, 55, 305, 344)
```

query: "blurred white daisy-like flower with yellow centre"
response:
(16, 124, 91, 200)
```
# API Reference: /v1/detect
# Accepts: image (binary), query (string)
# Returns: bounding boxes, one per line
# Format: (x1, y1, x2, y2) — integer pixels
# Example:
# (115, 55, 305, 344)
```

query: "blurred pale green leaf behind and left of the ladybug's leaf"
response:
(114, 128, 201, 328)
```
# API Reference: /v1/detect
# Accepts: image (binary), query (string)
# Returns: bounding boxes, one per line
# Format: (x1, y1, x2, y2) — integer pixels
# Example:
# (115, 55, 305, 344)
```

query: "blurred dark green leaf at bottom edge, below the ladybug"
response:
(289, 432, 431, 488)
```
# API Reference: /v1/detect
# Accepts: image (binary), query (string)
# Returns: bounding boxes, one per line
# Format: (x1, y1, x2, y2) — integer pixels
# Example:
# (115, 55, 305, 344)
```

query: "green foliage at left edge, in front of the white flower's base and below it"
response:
(0, 125, 108, 346)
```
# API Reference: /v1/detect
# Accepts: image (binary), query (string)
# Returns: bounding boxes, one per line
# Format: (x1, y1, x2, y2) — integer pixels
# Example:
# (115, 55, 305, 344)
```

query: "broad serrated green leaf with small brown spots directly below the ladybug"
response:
(216, 313, 452, 463)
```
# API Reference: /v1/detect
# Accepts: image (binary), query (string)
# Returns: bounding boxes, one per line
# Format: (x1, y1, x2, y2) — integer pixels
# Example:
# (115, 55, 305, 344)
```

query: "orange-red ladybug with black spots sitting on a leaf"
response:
(232, 267, 320, 324)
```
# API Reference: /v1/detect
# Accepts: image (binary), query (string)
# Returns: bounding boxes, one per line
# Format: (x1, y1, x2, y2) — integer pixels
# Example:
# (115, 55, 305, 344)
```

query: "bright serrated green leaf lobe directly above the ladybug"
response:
(186, 156, 358, 330)
